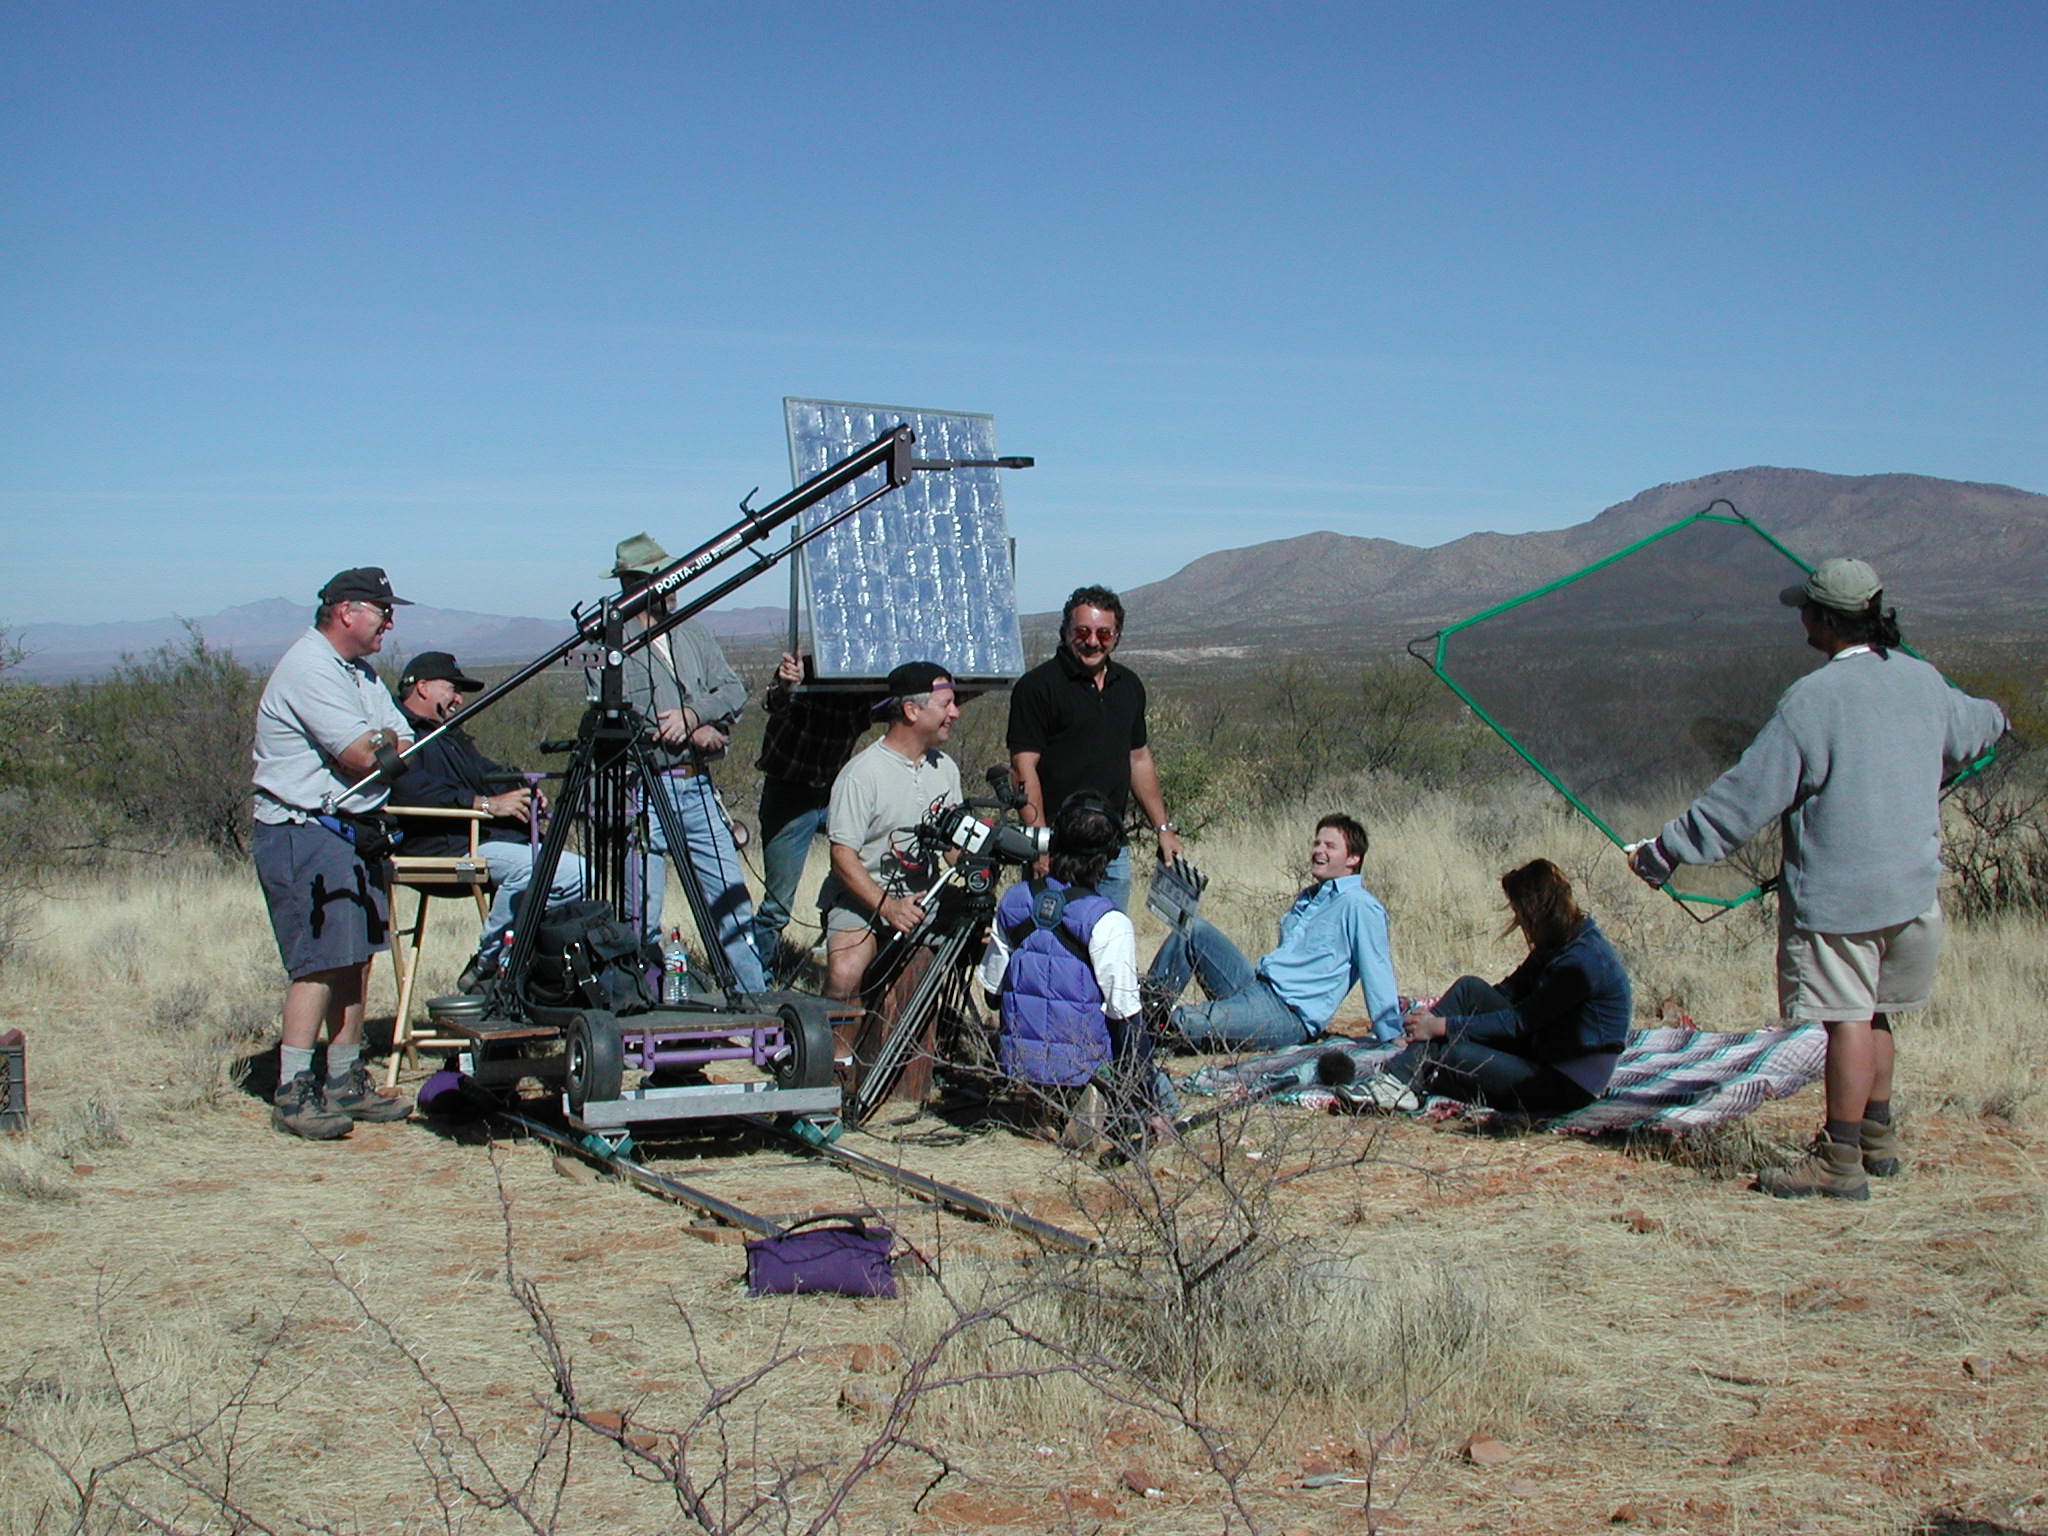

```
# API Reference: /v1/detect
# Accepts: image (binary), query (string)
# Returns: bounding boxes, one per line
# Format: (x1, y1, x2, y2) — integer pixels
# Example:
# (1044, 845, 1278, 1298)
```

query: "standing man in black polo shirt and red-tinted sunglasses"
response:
(1010, 586, 1180, 907)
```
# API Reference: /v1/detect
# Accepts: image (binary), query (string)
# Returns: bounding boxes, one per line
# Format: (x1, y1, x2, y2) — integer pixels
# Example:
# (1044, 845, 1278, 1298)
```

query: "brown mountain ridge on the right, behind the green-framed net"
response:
(1105, 467, 2048, 647)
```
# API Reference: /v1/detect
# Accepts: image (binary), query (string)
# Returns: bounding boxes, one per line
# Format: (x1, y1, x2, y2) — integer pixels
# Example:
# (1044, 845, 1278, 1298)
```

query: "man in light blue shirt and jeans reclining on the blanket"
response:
(1145, 815, 1401, 1051)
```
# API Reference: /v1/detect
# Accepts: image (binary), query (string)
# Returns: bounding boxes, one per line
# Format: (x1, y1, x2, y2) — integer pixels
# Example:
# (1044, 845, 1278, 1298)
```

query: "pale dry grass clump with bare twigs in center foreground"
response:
(905, 1110, 1559, 1442)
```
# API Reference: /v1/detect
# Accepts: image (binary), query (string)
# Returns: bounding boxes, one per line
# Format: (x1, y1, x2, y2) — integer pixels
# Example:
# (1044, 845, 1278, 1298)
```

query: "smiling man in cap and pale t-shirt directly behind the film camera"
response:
(817, 662, 961, 1001)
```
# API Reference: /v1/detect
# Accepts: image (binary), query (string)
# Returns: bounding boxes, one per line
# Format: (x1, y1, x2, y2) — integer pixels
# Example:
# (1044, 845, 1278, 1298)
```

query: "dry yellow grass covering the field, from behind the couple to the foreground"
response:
(0, 795, 2048, 1532)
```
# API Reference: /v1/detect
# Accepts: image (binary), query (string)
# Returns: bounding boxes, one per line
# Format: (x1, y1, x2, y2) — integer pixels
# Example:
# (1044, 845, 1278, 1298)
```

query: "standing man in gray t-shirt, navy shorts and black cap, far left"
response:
(250, 565, 412, 1141)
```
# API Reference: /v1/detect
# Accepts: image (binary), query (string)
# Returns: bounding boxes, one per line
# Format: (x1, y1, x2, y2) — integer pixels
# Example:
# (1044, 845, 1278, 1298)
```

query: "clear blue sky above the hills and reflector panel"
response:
(0, 0, 2048, 625)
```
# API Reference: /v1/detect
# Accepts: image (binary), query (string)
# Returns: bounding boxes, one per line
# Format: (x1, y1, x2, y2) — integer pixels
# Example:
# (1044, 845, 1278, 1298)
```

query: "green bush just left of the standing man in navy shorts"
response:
(57, 629, 262, 854)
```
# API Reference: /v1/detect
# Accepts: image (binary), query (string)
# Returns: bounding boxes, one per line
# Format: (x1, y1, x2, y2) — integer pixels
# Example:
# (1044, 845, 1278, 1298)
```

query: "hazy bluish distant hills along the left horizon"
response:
(12, 598, 788, 682)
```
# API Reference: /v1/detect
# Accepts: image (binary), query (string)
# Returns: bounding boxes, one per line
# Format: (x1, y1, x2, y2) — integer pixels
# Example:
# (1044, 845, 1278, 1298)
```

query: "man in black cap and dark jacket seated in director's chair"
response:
(391, 651, 584, 991)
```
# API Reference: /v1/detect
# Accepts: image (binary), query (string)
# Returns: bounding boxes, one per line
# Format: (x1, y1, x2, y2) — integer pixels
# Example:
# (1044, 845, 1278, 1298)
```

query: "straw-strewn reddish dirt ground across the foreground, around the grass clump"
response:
(0, 1001, 2048, 1536)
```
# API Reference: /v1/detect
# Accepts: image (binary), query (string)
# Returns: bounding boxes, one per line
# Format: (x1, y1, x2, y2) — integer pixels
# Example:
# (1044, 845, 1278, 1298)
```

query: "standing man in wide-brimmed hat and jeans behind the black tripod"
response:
(608, 532, 768, 993)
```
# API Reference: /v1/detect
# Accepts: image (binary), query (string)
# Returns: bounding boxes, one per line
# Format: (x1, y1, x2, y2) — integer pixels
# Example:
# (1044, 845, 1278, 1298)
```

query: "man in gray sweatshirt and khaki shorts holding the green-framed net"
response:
(1628, 559, 2005, 1200)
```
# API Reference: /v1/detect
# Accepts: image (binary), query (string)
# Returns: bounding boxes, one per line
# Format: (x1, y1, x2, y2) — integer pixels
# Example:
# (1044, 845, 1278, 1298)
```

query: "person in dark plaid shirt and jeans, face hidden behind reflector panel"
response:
(754, 651, 877, 967)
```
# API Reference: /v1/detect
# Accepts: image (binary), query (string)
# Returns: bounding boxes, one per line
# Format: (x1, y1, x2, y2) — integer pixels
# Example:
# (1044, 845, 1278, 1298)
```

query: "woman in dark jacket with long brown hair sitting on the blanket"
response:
(1366, 858, 1630, 1118)
